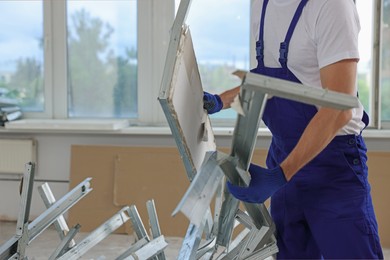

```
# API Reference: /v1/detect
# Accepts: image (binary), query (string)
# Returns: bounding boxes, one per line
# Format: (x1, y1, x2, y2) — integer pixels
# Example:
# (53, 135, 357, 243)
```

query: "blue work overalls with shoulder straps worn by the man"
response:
(252, 0, 383, 259)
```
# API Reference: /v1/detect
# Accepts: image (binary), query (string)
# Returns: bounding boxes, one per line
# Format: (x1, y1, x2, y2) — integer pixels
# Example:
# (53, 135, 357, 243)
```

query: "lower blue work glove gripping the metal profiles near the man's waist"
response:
(227, 164, 287, 203)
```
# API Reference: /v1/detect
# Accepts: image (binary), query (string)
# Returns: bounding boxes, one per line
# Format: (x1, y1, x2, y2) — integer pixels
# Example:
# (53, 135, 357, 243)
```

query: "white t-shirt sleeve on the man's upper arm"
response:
(315, 0, 360, 68)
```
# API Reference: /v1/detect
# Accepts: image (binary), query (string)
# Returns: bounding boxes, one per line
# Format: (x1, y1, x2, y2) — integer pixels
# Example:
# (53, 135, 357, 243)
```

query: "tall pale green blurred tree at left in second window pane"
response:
(68, 9, 113, 117)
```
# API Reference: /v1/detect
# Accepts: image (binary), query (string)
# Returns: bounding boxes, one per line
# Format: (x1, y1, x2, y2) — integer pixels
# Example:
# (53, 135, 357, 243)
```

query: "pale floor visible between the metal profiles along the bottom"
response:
(0, 222, 390, 260)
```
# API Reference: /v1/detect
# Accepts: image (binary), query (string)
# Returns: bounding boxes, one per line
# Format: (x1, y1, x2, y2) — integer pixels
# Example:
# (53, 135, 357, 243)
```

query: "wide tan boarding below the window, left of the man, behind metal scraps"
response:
(68, 145, 189, 236)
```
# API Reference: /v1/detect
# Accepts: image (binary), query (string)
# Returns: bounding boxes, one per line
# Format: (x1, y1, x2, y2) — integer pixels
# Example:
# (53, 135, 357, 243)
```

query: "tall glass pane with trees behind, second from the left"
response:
(67, 0, 138, 118)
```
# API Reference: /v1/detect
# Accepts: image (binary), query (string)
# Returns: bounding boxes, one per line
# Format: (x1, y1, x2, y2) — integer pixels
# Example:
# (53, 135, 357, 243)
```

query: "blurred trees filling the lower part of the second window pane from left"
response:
(68, 9, 137, 117)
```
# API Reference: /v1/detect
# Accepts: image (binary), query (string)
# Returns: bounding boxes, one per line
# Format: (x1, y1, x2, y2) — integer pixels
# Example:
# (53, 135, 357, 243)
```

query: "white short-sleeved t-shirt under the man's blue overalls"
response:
(251, 0, 364, 135)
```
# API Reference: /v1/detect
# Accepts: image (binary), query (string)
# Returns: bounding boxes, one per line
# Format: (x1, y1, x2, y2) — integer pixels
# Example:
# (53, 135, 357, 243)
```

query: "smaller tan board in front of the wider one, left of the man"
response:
(113, 148, 189, 236)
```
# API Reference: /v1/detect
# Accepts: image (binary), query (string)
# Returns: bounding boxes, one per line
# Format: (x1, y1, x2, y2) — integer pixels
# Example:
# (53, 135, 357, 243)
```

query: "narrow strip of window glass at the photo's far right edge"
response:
(381, 0, 390, 121)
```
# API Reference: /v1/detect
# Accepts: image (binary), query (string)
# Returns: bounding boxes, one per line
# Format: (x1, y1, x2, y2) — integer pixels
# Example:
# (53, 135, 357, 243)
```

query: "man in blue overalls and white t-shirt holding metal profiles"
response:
(204, 0, 383, 259)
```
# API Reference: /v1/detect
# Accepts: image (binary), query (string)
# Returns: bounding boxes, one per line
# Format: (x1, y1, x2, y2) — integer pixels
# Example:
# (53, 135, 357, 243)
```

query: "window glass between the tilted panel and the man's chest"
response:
(182, 0, 250, 119)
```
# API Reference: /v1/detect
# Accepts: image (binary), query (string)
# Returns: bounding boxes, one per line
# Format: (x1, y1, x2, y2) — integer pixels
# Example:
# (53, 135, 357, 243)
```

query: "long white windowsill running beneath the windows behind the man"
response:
(0, 119, 390, 139)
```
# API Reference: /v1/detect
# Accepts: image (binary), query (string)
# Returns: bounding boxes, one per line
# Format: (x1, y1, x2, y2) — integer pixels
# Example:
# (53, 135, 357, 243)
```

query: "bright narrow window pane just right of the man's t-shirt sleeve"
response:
(356, 0, 374, 120)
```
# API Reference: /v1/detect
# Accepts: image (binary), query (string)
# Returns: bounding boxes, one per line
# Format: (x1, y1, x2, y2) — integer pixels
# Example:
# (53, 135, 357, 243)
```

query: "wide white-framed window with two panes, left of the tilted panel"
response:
(0, 0, 174, 124)
